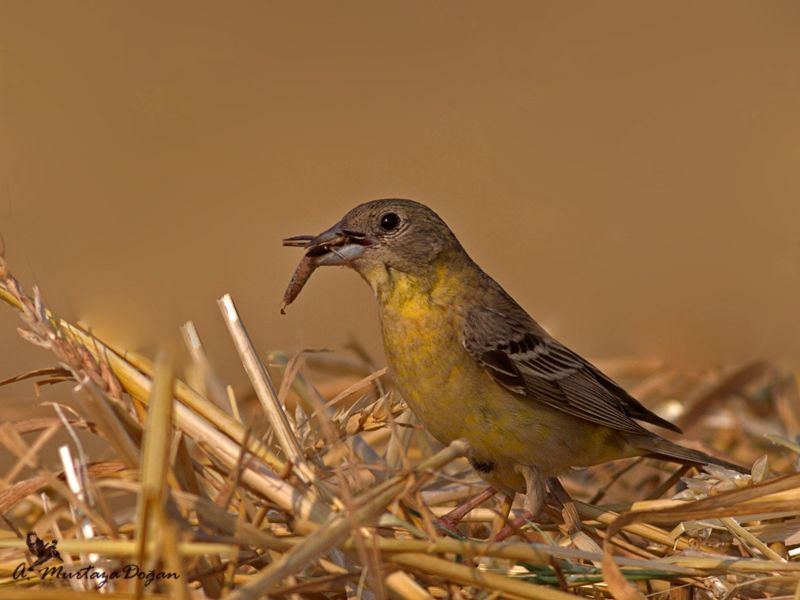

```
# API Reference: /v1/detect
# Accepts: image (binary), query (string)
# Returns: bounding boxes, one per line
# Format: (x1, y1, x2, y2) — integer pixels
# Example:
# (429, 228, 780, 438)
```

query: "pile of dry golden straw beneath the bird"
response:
(0, 245, 800, 600)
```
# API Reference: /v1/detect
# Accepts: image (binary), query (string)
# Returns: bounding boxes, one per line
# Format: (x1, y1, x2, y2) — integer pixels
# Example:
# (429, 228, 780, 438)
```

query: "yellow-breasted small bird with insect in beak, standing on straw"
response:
(282, 199, 742, 515)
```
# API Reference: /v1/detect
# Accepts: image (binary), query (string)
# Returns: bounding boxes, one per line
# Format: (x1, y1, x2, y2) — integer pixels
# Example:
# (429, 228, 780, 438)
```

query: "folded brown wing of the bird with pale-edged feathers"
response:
(463, 306, 680, 434)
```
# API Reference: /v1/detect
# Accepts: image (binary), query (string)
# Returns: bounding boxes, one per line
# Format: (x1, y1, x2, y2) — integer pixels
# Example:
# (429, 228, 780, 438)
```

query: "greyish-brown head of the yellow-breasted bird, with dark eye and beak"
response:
(284, 199, 461, 280)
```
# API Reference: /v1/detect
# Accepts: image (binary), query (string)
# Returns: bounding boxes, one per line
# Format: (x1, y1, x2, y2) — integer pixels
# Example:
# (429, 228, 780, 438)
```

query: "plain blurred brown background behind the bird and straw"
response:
(0, 1, 800, 408)
